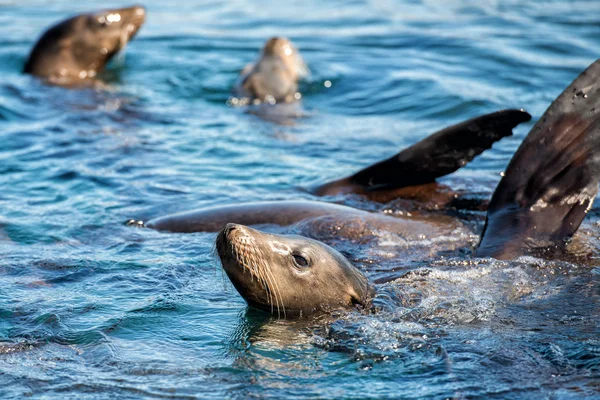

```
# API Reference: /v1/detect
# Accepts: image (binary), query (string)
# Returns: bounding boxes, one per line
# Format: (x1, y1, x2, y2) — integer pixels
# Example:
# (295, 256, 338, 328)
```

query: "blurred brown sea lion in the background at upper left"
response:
(24, 6, 146, 86)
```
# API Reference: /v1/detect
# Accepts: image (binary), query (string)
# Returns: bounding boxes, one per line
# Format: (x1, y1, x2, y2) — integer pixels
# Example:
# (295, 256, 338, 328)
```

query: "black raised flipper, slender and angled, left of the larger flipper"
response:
(313, 110, 531, 195)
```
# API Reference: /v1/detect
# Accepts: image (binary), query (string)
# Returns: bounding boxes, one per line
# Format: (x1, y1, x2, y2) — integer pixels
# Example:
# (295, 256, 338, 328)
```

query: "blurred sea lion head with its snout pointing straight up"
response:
(234, 37, 308, 104)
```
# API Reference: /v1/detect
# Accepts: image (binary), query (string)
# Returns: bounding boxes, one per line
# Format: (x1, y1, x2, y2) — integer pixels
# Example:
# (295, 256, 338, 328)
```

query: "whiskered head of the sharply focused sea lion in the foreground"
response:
(216, 224, 373, 316)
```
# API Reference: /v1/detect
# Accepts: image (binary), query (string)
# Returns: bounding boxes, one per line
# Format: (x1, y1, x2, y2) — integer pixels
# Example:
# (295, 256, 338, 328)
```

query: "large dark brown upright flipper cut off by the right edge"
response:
(477, 60, 600, 259)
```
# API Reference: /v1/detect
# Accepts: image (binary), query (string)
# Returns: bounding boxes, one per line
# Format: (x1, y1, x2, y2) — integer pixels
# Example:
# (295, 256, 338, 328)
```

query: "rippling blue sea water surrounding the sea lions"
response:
(0, 0, 600, 399)
